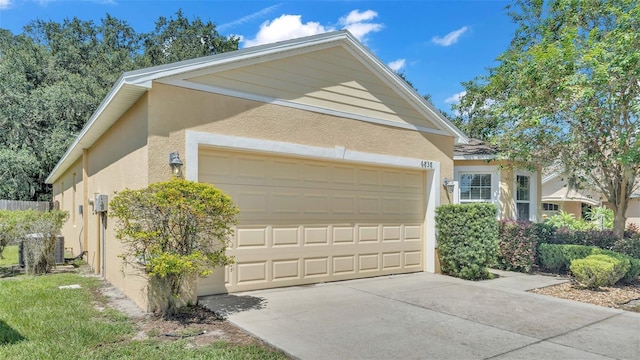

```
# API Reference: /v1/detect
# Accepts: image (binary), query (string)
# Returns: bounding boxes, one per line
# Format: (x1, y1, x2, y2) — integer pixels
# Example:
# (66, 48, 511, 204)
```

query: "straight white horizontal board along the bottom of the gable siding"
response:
(166, 79, 451, 135)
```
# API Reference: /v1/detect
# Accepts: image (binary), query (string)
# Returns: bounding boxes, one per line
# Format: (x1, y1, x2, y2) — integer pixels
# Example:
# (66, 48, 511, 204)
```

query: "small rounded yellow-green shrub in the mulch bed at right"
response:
(570, 254, 629, 289)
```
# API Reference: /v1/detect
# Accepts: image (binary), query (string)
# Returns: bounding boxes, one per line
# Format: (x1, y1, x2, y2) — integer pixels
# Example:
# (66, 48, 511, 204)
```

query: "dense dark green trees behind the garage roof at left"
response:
(0, 11, 239, 200)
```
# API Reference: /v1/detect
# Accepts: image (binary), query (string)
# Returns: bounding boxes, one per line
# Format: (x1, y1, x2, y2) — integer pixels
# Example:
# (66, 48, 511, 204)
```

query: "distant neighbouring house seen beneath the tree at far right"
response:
(542, 172, 640, 227)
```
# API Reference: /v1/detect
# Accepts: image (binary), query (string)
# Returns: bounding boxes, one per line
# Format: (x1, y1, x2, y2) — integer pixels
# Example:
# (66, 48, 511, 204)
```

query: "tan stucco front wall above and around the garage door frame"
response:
(149, 83, 453, 203)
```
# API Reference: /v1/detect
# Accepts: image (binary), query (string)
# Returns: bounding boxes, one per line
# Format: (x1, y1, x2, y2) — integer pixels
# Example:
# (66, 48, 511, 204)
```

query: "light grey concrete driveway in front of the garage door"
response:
(200, 272, 640, 360)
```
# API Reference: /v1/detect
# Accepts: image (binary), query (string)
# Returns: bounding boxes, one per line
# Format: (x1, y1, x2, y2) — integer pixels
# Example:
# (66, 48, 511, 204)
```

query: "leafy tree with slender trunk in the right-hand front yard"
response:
(461, 0, 640, 237)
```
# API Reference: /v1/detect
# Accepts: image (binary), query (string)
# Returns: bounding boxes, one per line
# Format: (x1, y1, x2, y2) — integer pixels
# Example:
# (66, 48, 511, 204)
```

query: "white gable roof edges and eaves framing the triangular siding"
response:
(46, 30, 468, 184)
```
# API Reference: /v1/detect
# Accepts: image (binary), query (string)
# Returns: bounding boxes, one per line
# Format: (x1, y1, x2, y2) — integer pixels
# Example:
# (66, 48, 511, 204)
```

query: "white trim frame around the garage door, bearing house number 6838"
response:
(185, 130, 441, 272)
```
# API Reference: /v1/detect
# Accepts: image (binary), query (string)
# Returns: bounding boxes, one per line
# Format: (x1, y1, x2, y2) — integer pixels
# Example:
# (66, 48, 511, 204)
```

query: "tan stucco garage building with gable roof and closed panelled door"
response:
(47, 31, 464, 308)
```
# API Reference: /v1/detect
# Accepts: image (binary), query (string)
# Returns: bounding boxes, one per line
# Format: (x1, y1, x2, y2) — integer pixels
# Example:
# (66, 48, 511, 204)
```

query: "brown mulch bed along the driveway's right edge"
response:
(531, 282, 640, 312)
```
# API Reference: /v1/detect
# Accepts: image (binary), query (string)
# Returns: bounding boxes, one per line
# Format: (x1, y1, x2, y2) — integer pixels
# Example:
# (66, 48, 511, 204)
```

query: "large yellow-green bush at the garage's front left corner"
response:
(110, 178, 238, 313)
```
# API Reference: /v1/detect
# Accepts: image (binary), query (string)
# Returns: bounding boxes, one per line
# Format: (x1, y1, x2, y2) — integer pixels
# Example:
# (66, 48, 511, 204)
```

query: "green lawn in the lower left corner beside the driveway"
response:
(0, 274, 285, 359)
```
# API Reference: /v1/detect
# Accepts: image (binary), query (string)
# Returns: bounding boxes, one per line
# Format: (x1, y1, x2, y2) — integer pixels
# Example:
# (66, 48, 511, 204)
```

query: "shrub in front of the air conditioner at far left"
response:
(0, 210, 69, 274)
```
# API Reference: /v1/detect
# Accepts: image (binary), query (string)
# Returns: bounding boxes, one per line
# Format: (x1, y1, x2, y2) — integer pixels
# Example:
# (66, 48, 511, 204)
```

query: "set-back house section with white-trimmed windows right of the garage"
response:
(449, 139, 541, 222)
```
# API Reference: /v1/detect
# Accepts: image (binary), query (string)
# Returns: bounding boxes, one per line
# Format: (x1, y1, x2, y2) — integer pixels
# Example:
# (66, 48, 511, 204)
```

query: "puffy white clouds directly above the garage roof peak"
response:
(244, 10, 384, 47)
